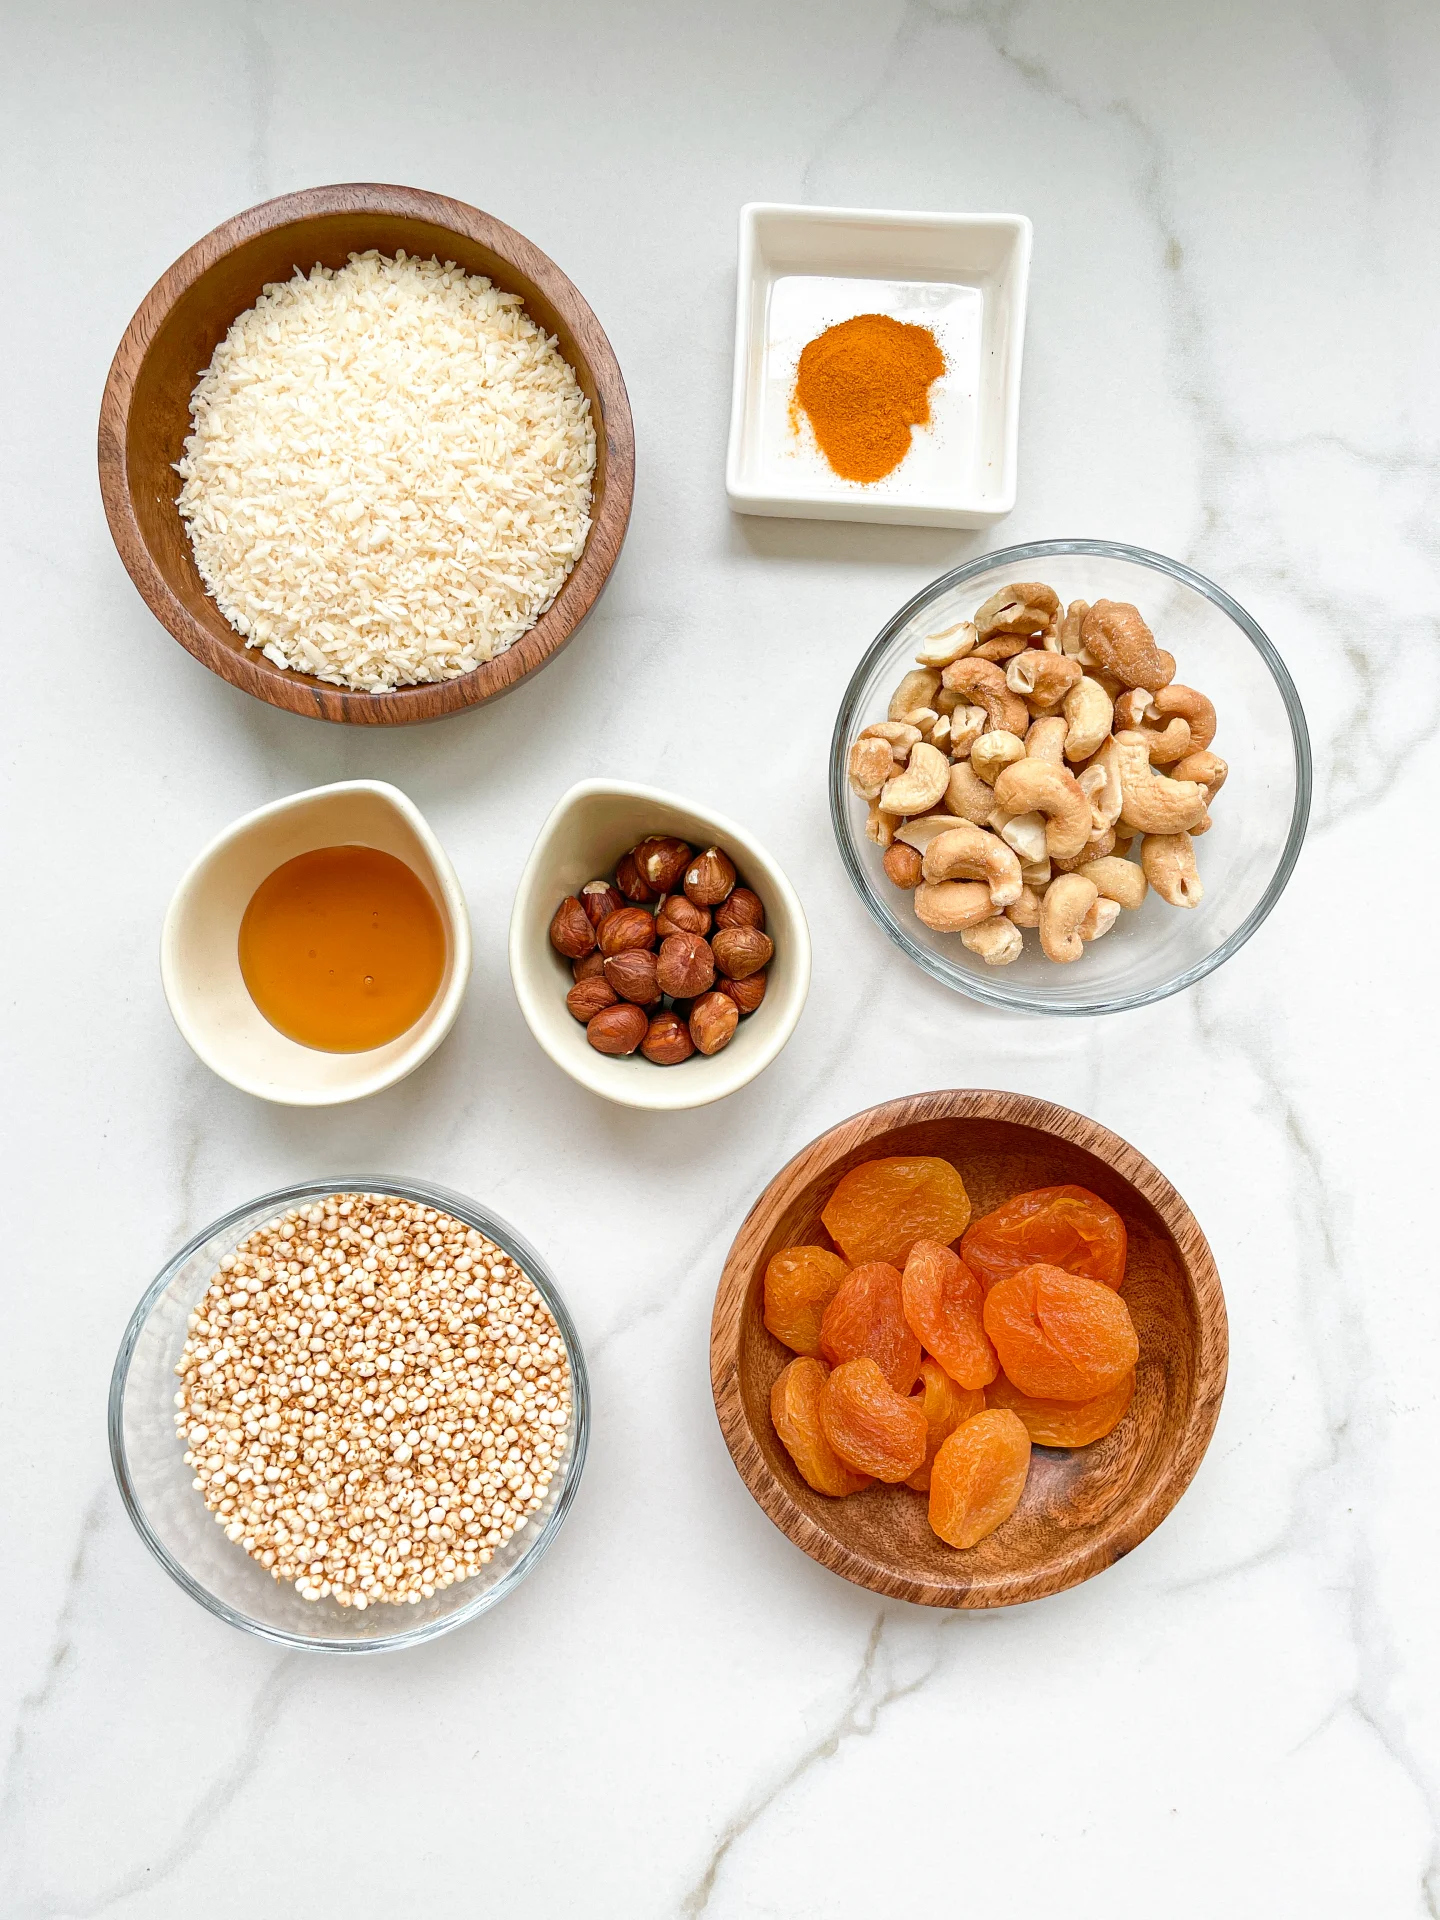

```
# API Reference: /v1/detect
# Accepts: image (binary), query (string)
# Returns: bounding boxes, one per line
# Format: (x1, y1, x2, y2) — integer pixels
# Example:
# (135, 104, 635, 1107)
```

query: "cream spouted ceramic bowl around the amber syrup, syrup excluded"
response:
(159, 780, 470, 1106)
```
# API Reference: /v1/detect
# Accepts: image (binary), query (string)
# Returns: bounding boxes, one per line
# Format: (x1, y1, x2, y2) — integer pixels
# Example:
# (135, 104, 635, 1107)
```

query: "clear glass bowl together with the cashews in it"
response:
(829, 540, 1311, 1014)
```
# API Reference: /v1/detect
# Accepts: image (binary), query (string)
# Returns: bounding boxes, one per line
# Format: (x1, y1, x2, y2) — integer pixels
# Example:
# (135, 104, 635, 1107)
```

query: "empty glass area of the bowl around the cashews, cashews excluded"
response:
(829, 540, 1311, 1014)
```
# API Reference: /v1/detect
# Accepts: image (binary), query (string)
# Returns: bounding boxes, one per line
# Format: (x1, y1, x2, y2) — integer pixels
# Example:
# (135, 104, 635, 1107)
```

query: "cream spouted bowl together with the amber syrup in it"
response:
(159, 780, 470, 1106)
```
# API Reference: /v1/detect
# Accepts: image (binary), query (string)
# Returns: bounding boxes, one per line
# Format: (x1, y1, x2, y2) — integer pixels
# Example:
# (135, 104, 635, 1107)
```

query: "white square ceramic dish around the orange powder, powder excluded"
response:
(726, 202, 1031, 526)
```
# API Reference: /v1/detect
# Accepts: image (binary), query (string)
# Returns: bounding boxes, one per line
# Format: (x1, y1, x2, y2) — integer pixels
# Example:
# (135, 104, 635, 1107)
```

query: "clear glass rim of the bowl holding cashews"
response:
(829, 538, 1313, 1020)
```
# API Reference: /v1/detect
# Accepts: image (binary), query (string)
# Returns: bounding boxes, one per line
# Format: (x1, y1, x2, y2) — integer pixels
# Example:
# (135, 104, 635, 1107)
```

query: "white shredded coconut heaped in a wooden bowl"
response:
(175, 252, 595, 693)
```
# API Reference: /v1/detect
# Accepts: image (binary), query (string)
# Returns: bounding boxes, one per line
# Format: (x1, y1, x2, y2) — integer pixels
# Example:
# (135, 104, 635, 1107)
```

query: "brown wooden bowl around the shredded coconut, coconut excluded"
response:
(100, 184, 636, 726)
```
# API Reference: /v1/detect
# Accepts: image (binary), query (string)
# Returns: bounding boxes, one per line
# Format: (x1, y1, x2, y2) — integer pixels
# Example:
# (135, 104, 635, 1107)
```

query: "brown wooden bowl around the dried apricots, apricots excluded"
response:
(710, 1092, 1229, 1607)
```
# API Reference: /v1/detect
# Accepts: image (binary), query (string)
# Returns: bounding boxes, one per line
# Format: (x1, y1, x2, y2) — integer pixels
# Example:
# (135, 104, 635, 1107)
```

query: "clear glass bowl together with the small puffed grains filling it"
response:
(109, 1179, 589, 1653)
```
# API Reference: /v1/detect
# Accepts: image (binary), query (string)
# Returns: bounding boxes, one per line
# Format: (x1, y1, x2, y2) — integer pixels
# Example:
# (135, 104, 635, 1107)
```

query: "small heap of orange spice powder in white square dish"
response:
(791, 313, 945, 484)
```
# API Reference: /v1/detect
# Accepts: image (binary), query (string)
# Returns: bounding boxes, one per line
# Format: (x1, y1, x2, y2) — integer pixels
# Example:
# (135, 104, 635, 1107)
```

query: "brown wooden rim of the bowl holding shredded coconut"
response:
(98, 180, 636, 726)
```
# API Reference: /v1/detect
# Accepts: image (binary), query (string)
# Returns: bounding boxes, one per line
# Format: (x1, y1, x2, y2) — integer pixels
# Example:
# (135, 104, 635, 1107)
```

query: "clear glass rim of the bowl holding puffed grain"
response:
(106, 1175, 589, 1653)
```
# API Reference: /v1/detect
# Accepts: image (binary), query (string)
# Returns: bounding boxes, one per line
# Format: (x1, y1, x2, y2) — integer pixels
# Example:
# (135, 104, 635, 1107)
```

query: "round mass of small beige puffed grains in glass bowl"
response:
(175, 1194, 570, 1609)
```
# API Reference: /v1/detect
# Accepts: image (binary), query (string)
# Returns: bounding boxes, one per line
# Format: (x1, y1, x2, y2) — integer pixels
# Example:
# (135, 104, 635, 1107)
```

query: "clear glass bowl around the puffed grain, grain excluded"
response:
(109, 1177, 589, 1653)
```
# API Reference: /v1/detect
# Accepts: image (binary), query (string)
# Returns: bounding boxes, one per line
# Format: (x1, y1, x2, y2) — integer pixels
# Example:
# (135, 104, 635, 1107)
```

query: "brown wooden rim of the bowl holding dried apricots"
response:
(710, 1089, 1229, 1607)
